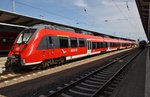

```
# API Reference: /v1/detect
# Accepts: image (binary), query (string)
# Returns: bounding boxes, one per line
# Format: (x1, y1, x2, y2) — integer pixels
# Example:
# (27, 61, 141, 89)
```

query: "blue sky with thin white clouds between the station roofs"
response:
(0, 0, 147, 40)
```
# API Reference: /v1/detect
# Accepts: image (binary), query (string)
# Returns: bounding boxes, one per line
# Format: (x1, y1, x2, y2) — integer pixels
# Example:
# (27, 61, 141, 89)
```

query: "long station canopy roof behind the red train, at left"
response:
(0, 10, 134, 41)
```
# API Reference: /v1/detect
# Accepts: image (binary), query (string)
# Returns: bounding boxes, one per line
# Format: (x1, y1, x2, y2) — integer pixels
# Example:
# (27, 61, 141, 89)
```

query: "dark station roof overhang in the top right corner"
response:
(136, 0, 150, 41)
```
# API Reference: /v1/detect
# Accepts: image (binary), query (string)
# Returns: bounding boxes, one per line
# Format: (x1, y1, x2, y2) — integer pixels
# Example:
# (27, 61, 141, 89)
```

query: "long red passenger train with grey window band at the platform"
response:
(5, 24, 135, 69)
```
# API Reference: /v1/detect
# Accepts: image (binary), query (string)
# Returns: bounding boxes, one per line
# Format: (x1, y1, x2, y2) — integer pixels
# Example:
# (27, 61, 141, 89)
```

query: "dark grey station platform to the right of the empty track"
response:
(111, 47, 150, 97)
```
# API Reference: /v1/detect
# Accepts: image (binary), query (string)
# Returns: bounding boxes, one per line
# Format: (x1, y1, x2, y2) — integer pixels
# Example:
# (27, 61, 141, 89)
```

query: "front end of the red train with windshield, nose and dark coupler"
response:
(5, 28, 36, 71)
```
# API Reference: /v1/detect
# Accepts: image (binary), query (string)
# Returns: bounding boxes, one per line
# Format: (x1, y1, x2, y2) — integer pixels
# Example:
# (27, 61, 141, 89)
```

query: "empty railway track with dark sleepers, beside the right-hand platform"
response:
(40, 51, 142, 97)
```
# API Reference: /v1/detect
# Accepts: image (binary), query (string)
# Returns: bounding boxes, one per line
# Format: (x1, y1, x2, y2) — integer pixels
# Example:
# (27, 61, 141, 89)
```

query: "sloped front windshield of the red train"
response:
(17, 29, 36, 44)
